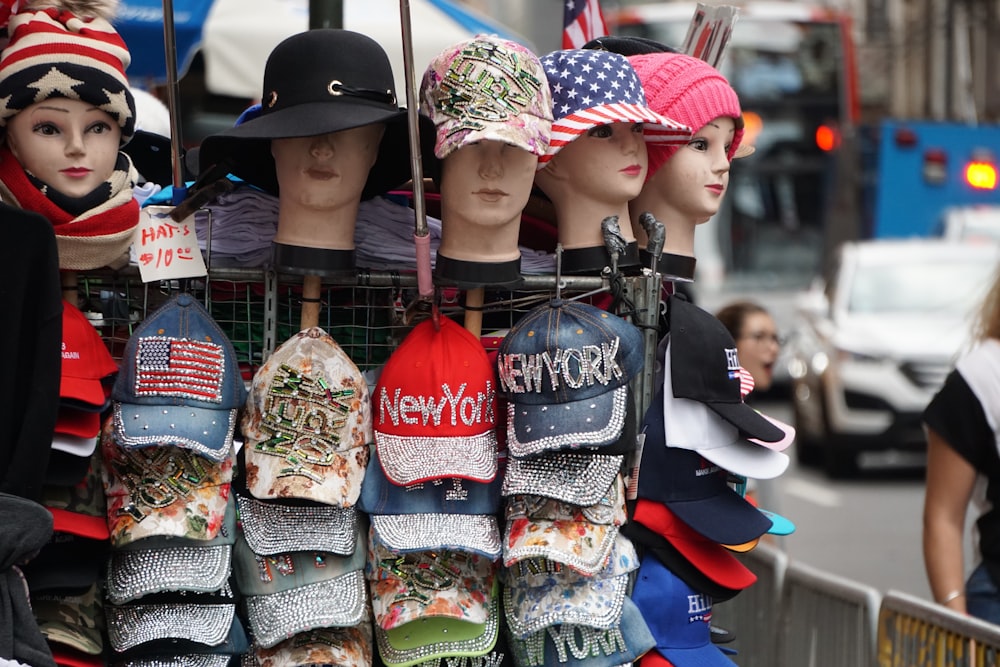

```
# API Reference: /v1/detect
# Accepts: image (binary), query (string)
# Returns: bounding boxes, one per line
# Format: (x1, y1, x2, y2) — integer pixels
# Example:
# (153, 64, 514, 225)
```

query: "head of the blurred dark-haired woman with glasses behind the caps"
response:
(715, 301, 781, 396)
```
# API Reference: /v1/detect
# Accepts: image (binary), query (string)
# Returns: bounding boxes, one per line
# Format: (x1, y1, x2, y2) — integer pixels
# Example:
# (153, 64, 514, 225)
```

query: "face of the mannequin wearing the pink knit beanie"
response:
(646, 117, 736, 224)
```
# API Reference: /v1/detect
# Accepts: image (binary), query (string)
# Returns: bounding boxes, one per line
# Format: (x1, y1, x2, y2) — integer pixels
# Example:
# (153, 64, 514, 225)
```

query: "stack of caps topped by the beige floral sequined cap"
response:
(233, 327, 372, 667)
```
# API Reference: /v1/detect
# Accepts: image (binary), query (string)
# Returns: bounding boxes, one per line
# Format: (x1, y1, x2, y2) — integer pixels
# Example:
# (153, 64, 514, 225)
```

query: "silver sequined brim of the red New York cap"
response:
(375, 430, 497, 486)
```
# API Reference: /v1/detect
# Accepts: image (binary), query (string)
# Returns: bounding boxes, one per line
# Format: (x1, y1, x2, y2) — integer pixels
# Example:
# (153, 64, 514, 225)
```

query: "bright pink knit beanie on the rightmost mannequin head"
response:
(628, 53, 743, 179)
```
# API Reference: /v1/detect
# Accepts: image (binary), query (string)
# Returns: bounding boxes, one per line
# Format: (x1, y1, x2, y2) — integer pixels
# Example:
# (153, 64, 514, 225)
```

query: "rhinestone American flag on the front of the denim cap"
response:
(135, 336, 225, 403)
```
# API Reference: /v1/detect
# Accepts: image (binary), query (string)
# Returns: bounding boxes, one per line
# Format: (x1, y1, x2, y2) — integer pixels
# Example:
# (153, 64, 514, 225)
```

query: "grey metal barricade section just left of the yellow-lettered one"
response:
(773, 562, 881, 667)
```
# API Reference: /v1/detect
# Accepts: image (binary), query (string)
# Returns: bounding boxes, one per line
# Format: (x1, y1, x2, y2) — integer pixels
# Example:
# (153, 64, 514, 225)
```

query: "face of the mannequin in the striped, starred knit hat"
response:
(7, 97, 121, 197)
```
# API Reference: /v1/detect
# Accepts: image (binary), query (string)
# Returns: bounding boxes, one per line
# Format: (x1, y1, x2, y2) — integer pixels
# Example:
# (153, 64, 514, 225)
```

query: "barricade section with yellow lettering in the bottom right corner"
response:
(877, 591, 1000, 667)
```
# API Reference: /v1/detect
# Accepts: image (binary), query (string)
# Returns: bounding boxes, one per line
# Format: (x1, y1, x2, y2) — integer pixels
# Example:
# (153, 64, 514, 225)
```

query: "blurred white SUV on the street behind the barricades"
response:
(786, 239, 1000, 476)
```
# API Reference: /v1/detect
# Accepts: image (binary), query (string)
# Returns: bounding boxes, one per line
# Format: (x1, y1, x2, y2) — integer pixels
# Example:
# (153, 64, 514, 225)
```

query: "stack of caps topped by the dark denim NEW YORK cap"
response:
(497, 300, 652, 667)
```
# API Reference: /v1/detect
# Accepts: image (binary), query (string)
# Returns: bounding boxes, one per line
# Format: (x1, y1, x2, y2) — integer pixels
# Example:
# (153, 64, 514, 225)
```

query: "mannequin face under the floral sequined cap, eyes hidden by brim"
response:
(441, 140, 538, 227)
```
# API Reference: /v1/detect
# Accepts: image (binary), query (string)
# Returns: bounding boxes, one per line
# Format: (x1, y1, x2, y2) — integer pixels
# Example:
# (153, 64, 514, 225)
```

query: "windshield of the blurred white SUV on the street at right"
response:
(847, 260, 996, 314)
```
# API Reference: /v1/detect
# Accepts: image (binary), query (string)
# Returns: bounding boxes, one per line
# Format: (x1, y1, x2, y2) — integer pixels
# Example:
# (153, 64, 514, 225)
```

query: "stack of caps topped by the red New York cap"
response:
(362, 317, 502, 667)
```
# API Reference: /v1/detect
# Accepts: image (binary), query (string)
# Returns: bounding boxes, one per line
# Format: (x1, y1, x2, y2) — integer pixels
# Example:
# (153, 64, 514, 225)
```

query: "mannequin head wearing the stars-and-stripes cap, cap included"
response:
(535, 50, 689, 272)
